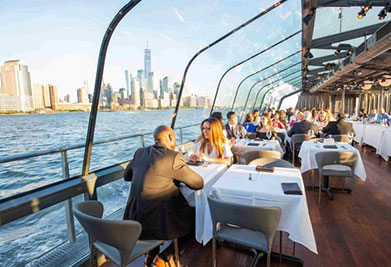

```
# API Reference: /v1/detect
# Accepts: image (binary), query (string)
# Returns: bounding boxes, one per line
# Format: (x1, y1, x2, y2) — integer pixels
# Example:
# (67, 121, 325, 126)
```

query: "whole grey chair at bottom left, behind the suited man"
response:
(73, 201, 163, 266)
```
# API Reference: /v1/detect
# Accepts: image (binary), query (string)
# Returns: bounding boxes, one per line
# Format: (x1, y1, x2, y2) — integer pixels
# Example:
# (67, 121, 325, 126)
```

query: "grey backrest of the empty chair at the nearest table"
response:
(208, 195, 281, 251)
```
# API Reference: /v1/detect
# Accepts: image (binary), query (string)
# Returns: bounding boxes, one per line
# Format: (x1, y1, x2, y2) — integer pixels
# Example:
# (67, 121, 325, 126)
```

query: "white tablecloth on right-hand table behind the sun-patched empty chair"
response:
(299, 141, 367, 181)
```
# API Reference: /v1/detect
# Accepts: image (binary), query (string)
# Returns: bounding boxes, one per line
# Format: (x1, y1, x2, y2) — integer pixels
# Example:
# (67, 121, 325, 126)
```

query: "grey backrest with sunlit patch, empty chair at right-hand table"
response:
(315, 151, 357, 174)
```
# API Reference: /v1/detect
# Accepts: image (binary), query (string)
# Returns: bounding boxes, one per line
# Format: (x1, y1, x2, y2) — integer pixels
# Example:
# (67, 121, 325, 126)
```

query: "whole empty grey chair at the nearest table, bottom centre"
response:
(208, 196, 281, 267)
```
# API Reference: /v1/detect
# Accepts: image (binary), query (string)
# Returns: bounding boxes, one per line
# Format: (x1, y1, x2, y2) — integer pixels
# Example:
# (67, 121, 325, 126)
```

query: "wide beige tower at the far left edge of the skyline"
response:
(0, 60, 34, 111)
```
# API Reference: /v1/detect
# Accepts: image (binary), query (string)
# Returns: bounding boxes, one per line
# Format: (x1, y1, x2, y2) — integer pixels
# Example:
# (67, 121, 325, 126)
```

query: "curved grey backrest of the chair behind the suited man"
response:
(73, 201, 142, 261)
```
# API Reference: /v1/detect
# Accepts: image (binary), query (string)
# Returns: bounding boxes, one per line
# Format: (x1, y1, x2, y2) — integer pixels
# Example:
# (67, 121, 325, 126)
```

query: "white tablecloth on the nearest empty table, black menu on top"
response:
(211, 165, 318, 253)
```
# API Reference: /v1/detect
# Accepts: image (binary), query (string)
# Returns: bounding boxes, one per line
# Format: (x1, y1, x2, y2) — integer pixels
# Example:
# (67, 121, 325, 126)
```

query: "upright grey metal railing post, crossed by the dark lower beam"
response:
(61, 150, 76, 244)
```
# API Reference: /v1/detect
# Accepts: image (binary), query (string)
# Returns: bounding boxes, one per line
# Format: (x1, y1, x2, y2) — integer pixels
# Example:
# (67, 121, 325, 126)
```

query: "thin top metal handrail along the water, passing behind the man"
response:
(0, 123, 199, 164)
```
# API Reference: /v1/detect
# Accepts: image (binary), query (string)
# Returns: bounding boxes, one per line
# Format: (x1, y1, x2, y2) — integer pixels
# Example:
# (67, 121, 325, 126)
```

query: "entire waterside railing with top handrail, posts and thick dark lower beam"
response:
(0, 123, 199, 243)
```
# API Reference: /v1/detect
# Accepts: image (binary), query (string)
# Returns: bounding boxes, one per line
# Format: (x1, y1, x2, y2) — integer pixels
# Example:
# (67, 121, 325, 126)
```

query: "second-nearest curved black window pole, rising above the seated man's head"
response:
(171, 0, 288, 129)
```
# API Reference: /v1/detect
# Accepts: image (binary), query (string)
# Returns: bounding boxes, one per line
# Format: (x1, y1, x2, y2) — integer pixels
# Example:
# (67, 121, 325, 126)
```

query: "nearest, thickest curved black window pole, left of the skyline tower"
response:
(82, 0, 141, 179)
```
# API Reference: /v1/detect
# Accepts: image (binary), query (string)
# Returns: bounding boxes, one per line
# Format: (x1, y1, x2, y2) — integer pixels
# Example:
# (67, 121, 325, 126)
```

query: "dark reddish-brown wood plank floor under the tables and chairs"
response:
(107, 147, 391, 267)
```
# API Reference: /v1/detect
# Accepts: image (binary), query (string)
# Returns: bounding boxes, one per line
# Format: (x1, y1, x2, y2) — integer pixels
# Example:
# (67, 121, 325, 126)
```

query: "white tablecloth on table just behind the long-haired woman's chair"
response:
(231, 139, 284, 164)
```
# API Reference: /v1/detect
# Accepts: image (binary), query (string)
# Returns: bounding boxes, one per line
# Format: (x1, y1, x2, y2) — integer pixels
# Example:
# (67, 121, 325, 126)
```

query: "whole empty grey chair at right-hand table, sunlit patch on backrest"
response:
(315, 151, 357, 203)
